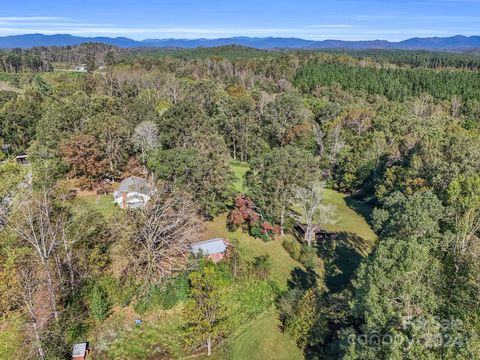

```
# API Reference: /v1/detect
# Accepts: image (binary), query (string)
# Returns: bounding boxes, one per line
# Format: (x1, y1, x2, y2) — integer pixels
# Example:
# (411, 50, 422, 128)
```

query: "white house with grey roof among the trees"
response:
(113, 176, 152, 209)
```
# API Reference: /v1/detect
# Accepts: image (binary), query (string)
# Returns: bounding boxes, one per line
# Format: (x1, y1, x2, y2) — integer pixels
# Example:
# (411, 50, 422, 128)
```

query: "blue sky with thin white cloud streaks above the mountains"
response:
(0, 0, 480, 41)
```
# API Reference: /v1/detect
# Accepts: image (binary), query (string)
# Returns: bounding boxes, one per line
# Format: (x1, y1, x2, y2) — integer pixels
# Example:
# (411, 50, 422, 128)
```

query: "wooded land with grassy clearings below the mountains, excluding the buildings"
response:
(0, 44, 480, 360)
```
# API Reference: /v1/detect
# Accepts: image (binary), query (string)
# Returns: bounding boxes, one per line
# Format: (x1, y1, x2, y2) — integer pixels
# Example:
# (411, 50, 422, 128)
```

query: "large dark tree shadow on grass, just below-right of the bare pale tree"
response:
(317, 232, 365, 293)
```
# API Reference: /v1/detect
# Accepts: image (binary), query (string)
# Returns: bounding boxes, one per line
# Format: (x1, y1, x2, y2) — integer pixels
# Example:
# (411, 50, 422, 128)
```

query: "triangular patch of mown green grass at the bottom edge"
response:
(207, 310, 304, 360)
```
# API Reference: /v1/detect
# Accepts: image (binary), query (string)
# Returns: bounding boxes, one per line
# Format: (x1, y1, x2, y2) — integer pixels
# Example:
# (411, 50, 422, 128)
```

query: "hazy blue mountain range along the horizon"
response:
(0, 34, 480, 50)
